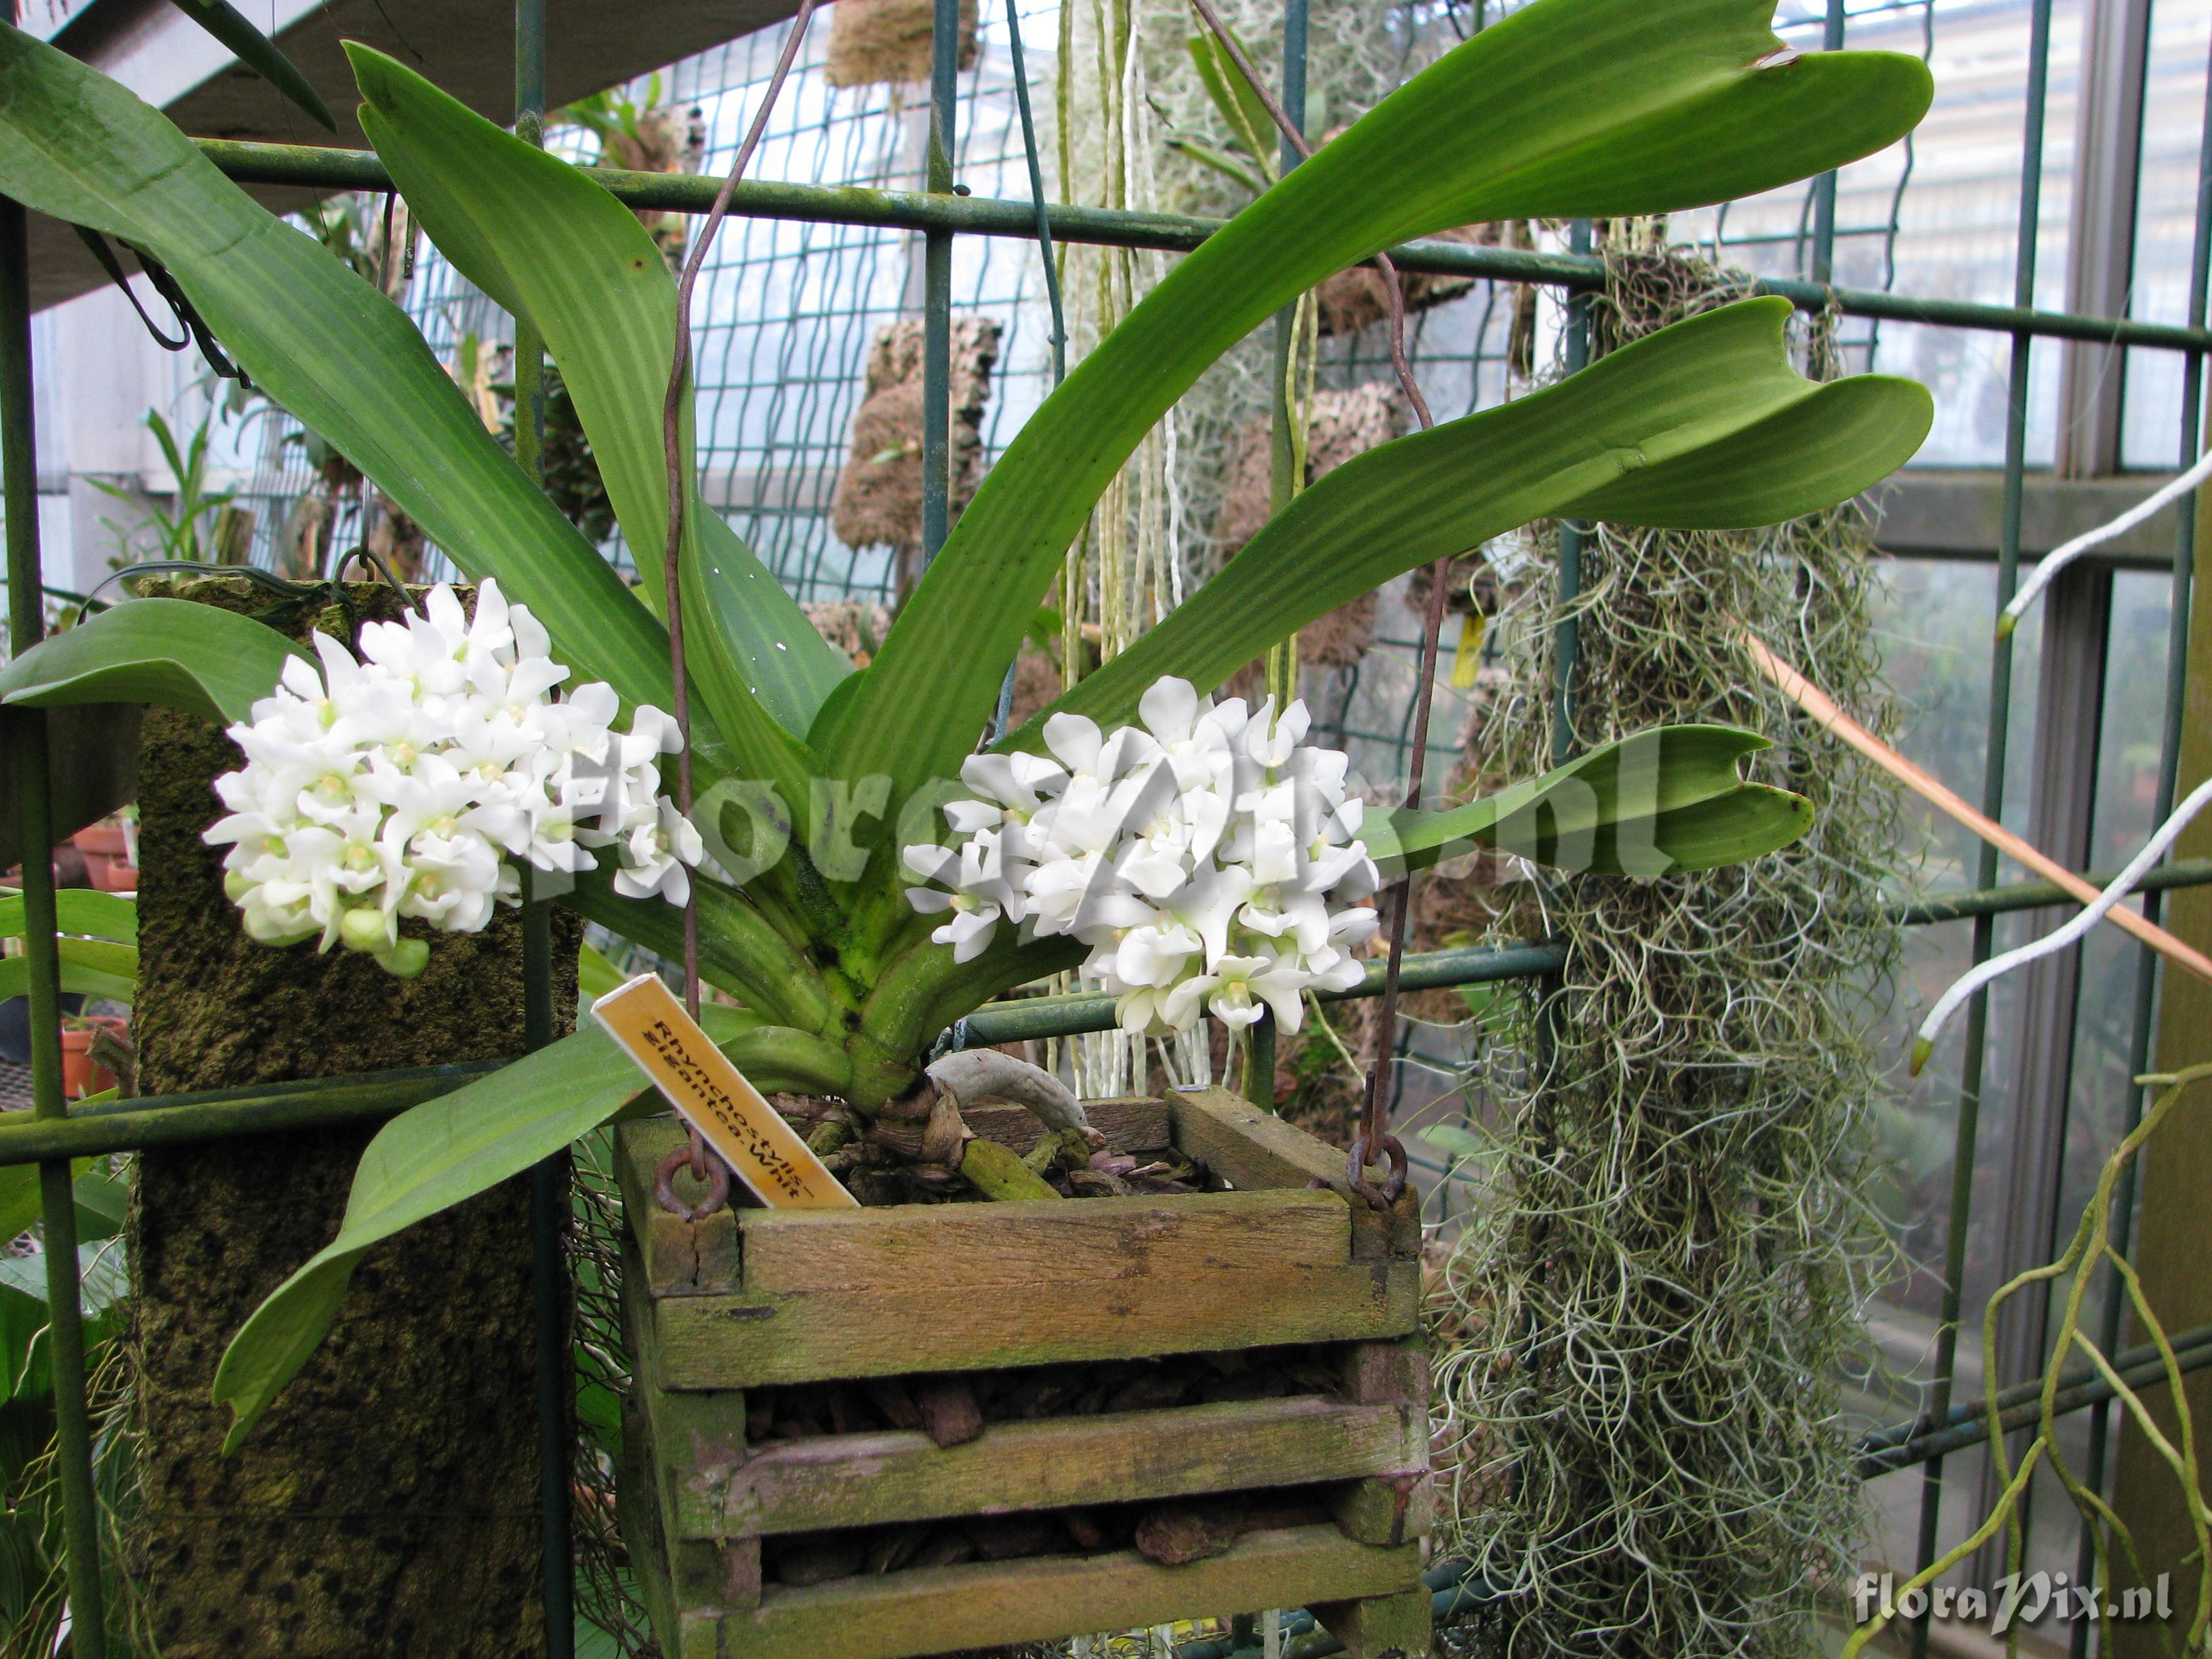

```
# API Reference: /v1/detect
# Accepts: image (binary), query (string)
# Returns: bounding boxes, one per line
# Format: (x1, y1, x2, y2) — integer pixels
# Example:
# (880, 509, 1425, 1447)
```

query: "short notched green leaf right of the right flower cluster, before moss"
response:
(1360, 726, 1811, 876)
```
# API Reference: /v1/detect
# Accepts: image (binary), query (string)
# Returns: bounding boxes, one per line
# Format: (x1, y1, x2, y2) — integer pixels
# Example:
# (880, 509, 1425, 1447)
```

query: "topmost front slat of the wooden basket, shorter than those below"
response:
(745, 1192, 1351, 1309)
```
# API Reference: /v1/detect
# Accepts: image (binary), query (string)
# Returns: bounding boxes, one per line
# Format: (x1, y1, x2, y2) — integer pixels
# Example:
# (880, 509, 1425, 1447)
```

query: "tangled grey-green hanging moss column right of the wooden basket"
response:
(1431, 234, 1900, 1659)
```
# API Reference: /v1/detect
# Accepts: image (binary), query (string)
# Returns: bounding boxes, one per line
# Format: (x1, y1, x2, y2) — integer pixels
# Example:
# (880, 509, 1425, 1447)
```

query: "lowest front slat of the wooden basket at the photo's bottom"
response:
(716, 1526, 1420, 1659)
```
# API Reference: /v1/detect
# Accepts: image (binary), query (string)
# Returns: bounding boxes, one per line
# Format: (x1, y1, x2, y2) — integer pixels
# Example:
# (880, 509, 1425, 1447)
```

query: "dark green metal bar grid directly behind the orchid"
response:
(0, 0, 2212, 1659)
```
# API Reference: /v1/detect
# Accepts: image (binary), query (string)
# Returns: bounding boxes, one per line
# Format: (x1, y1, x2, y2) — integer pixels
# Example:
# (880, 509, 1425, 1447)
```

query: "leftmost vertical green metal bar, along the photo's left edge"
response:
(0, 169, 108, 1659)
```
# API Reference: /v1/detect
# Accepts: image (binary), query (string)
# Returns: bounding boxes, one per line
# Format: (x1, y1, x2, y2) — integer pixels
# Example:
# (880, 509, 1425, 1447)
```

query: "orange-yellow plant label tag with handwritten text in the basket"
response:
(590, 973, 861, 1210)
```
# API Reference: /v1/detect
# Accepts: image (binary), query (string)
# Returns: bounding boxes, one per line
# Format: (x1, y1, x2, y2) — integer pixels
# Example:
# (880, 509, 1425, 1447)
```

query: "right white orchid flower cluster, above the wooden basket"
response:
(905, 679, 1380, 1033)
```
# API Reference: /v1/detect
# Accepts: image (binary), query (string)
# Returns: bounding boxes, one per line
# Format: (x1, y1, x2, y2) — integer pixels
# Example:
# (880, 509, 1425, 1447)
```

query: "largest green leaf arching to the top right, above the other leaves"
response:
(827, 0, 1931, 814)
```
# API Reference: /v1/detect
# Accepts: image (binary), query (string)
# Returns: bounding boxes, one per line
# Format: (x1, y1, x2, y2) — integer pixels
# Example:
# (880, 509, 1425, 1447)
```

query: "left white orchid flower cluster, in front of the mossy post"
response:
(203, 579, 701, 978)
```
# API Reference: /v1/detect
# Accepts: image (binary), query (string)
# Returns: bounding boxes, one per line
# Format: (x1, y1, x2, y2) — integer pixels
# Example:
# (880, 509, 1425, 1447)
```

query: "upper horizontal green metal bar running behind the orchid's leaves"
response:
(181, 140, 2212, 352)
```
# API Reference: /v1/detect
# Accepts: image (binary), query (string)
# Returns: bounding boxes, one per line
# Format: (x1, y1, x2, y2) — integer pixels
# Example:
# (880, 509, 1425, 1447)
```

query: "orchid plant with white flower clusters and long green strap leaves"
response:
(0, 0, 1931, 1433)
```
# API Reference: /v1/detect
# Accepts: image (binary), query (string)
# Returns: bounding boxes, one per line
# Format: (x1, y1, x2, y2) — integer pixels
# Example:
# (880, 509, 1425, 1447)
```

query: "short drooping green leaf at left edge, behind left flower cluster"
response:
(0, 600, 314, 726)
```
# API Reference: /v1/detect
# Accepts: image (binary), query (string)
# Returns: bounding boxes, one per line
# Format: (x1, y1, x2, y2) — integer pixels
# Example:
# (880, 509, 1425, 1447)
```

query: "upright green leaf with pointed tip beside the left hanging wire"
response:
(345, 42, 852, 760)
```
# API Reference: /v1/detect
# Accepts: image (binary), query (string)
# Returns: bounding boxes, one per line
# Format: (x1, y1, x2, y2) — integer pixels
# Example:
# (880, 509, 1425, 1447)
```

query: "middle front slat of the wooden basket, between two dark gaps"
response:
(672, 1396, 1429, 1537)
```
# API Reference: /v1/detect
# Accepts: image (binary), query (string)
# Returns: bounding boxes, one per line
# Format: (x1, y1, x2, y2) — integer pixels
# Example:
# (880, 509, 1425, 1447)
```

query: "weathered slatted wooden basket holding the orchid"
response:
(617, 1090, 1431, 1659)
